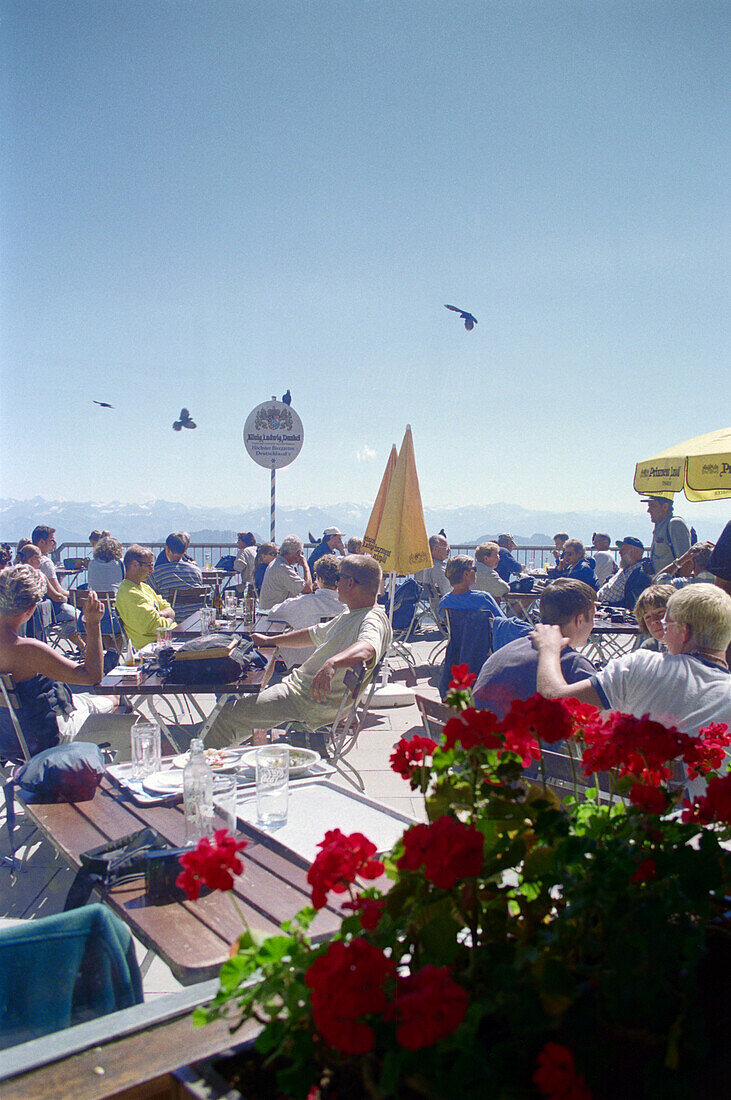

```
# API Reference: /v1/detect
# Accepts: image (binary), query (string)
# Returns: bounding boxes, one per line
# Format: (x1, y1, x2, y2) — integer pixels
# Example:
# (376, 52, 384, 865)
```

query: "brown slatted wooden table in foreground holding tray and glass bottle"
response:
(19, 779, 340, 986)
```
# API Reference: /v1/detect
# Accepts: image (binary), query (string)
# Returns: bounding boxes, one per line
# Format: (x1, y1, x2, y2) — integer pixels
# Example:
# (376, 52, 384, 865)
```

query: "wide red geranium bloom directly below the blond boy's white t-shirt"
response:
(583, 714, 694, 787)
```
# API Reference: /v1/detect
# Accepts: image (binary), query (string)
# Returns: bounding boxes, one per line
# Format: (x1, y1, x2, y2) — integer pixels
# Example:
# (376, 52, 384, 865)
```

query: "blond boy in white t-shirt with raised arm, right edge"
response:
(531, 584, 731, 765)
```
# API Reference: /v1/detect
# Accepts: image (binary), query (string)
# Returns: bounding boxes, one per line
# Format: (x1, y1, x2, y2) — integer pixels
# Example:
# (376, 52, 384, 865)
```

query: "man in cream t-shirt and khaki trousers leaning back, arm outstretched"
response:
(206, 554, 391, 748)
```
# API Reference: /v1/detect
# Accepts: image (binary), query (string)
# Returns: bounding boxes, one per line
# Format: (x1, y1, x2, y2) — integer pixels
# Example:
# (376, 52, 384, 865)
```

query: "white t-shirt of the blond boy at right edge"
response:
(591, 649, 731, 737)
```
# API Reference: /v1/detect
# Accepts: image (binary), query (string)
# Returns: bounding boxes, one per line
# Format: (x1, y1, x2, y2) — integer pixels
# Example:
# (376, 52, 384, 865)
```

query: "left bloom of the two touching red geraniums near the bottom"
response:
(304, 939, 396, 1054)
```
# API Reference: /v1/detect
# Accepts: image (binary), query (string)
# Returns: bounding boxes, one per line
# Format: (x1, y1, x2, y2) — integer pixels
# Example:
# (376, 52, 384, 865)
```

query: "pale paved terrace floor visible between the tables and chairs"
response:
(0, 629, 440, 1000)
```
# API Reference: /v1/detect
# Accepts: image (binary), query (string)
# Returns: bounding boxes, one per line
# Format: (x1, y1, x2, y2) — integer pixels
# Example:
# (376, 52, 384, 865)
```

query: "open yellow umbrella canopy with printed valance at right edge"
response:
(634, 428, 731, 501)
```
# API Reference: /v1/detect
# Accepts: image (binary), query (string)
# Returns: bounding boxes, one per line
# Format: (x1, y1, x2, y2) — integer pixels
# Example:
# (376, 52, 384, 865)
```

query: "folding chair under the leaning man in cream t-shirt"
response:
(283, 659, 383, 791)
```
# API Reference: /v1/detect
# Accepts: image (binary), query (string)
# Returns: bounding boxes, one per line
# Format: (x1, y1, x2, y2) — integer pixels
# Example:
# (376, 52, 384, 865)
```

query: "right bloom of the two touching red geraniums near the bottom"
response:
(391, 966, 469, 1051)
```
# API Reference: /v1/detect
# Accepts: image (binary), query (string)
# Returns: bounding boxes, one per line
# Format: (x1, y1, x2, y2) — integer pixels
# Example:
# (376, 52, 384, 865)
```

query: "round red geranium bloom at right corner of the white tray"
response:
(398, 814, 484, 890)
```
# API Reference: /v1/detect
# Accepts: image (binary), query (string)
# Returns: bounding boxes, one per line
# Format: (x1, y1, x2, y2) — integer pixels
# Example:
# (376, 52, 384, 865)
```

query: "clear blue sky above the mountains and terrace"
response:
(0, 0, 731, 524)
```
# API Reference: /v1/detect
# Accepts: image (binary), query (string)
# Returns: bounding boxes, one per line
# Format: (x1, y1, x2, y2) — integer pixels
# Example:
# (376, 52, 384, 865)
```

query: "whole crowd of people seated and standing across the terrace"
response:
(0, 510, 731, 787)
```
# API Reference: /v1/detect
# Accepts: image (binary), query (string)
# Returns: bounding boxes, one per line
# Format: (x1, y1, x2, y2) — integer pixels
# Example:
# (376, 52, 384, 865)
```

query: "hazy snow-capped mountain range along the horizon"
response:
(0, 496, 720, 546)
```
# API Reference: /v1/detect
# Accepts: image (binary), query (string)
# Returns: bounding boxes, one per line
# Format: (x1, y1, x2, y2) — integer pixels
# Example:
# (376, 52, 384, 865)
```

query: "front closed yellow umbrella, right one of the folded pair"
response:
(370, 425, 432, 573)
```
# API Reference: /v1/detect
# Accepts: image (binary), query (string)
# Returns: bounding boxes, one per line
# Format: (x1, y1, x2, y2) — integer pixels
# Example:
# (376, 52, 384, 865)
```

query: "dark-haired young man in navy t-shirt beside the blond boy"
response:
(474, 580, 596, 718)
